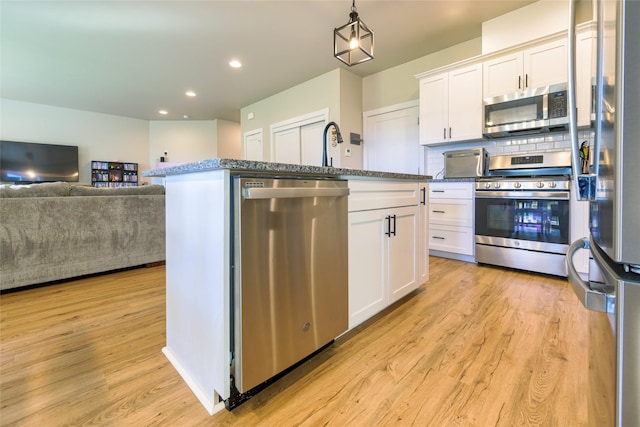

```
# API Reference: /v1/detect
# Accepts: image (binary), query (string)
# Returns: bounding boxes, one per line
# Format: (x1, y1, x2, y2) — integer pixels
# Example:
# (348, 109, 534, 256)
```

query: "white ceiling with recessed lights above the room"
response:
(0, 0, 533, 121)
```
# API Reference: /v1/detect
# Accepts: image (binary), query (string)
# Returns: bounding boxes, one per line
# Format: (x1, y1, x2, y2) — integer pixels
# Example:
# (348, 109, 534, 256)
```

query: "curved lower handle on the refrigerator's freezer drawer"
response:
(566, 237, 615, 313)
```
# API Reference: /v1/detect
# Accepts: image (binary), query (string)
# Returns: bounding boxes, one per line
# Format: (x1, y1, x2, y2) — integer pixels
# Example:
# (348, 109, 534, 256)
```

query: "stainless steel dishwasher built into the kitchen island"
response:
(227, 177, 349, 407)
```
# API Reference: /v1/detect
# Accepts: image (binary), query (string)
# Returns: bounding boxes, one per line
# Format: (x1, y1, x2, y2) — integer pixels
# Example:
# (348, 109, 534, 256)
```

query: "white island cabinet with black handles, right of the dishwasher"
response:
(349, 181, 421, 328)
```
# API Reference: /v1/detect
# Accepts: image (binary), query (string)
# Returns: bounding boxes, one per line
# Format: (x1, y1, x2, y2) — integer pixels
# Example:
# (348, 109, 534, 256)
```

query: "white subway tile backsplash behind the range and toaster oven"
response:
(424, 129, 593, 178)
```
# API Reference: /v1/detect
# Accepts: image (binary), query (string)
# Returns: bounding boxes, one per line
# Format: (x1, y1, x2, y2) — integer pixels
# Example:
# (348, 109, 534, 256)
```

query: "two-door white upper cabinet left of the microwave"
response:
(420, 64, 482, 145)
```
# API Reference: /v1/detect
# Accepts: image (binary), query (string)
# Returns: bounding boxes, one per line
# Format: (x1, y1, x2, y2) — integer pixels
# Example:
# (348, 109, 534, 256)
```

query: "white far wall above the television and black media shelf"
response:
(0, 98, 150, 184)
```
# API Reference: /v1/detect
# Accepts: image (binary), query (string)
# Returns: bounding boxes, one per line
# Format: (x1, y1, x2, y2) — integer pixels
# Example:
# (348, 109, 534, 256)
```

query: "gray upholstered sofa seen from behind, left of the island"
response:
(0, 182, 165, 291)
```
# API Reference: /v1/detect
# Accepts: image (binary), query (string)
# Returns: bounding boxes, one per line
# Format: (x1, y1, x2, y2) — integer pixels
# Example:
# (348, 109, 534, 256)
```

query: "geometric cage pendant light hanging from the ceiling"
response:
(333, 0, 373, 67)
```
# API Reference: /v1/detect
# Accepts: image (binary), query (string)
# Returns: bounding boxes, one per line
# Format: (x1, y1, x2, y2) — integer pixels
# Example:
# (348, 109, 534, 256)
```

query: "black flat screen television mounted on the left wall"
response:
(0, 141, 79, 184)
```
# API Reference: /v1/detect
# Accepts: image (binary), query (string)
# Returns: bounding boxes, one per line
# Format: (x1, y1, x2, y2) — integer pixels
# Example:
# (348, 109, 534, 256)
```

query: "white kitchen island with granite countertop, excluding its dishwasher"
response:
(143, 159, 430, 413)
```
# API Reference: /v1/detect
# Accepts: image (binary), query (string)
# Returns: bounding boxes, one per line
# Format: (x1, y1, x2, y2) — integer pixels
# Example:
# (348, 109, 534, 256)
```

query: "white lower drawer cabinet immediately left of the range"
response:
(428, 182, 475, 261)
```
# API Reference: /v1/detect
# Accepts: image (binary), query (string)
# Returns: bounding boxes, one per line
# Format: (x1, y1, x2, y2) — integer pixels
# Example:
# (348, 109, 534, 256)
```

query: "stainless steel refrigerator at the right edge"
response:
(567, 0, 640, 426)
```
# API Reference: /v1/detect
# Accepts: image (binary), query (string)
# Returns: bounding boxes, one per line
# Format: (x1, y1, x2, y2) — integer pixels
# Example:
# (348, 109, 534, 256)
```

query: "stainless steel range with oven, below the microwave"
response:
(475, 152, 571, 277)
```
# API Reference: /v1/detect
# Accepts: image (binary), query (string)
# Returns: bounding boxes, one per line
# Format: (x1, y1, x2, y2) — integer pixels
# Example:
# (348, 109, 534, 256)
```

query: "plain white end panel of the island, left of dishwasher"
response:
(163, 170, 231, 413)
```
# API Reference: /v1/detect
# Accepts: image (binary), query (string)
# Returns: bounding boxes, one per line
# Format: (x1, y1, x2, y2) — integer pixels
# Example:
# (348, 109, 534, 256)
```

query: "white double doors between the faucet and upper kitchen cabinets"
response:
(363, 105, 423, 174)
